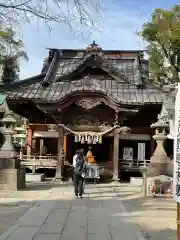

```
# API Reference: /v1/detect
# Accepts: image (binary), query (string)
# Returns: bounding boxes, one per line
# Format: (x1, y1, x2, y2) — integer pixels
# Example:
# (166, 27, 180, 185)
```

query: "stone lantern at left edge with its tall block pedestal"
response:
(0, 112, 25, 190)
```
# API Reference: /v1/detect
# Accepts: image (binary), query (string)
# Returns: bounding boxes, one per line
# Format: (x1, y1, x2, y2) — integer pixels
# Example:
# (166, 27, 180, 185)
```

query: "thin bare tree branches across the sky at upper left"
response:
(0, 0, 102, 36)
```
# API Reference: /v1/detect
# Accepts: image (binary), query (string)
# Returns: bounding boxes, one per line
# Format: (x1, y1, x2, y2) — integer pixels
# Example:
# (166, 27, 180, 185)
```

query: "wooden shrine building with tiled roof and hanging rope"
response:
(1, 42, 172, 179)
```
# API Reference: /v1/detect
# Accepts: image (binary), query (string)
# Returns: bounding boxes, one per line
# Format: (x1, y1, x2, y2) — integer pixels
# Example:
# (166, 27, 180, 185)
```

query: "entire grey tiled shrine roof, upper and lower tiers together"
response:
(0, 45, 172, 105)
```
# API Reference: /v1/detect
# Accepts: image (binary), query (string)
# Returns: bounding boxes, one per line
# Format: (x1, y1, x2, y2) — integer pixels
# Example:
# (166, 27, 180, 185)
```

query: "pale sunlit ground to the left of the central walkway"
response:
(0, 181, 55, 235)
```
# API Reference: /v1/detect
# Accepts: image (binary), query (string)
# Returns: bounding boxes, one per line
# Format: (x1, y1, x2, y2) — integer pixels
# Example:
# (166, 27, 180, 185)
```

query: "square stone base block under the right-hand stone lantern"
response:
(147, 163, 173, 177)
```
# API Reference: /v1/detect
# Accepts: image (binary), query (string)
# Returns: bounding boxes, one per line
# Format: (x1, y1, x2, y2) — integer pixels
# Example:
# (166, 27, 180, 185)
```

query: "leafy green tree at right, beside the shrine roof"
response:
(139, 5, 180, 85)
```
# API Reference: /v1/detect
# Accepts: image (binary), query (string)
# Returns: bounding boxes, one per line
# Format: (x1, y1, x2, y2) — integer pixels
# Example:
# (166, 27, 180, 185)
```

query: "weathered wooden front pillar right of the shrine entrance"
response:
(112, 129, 119, 181)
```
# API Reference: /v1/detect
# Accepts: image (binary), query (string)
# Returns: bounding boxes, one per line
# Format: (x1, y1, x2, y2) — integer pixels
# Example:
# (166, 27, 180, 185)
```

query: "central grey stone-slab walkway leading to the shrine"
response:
(0, 185, 144, 240)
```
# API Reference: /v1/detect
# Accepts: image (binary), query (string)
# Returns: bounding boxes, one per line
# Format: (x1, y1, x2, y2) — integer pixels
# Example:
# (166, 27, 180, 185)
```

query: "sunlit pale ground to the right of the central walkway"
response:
(114, 185, 176, 240)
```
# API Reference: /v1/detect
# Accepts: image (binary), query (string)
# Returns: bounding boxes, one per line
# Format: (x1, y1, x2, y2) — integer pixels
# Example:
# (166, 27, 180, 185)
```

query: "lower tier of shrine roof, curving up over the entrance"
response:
(7, 79, 168, 105)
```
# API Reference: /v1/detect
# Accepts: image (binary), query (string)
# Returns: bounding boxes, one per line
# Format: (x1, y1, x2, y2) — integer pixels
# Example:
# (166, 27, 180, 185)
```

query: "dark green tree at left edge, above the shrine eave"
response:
(0, 29, 28, 83)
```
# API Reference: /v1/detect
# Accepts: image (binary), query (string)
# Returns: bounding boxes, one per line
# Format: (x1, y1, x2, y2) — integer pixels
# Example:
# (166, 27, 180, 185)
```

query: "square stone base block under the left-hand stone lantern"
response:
(0, 168, 26, 191)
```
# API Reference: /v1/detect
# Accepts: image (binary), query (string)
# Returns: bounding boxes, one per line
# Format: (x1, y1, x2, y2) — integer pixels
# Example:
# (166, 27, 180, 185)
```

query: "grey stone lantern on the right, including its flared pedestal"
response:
(147, 106, 172, 177)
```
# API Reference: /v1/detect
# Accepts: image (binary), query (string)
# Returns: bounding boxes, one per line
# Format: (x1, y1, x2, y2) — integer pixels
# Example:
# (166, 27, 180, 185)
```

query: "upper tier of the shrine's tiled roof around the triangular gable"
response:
(38, 45, 143, 85)
